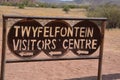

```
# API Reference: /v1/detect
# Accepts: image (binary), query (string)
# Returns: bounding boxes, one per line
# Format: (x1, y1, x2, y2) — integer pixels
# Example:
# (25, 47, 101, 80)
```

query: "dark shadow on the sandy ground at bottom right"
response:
(65, 73, 120, 80)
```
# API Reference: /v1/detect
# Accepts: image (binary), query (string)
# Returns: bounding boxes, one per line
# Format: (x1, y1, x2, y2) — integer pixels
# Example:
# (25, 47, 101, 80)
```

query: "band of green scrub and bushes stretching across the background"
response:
(0, 0, 120, 28)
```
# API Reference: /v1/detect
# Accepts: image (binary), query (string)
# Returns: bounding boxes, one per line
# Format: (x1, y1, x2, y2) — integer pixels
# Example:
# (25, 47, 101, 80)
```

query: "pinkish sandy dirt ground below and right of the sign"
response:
(0, 5, 120, 80)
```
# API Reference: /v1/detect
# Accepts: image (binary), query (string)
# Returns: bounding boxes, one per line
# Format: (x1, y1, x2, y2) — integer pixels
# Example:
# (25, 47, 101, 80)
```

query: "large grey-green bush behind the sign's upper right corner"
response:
(87, 4, 120, 28)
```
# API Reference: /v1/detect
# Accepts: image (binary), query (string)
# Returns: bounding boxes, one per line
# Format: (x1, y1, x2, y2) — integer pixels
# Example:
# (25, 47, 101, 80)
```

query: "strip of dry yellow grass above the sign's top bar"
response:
(0, 6, 86, 17)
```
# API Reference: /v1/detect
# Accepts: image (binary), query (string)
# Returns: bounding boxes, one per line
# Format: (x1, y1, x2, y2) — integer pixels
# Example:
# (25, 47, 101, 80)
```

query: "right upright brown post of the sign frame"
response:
(97, 21, 106, 80)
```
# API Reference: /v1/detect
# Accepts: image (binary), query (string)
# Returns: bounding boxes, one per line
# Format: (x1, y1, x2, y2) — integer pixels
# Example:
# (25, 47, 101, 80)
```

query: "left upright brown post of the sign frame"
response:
(0, 16, 6, 80)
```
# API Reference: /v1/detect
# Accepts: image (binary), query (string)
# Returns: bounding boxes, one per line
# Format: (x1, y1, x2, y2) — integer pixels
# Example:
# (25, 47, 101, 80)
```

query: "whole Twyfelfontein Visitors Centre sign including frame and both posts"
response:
(0, 15, 107, 80)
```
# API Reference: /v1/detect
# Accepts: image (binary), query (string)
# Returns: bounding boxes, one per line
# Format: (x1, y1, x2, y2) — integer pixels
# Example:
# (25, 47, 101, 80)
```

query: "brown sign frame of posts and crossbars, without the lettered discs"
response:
(0, 15, 107, 80)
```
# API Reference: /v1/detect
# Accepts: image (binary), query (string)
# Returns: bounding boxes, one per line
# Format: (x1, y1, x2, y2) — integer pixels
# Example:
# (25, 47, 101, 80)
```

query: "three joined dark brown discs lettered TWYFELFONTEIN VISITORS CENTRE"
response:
(7, 19, 101, 58)
